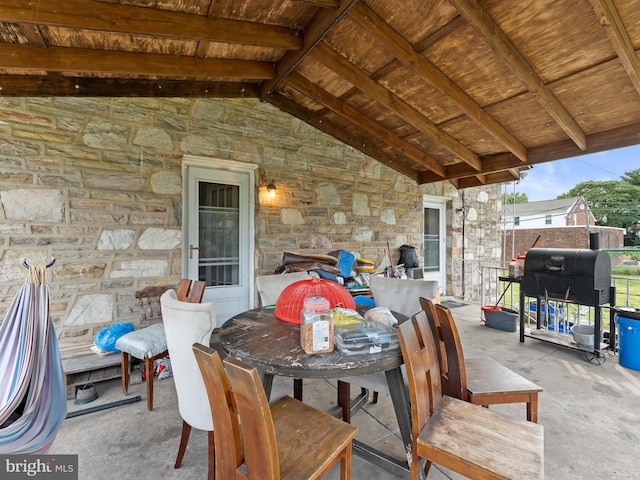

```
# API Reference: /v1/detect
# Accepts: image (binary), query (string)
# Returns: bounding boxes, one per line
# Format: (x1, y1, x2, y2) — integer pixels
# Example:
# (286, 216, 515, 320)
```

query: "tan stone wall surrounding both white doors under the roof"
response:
(0, 97, 500, 342)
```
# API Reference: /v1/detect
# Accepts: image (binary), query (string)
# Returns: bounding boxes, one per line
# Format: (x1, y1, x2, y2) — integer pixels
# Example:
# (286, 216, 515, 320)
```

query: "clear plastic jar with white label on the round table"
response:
(300, 297, 333, 355)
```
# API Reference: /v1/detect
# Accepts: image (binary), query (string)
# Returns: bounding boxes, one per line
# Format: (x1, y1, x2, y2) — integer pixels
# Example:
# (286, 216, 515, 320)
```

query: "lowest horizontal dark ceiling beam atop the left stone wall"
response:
(0, 74, 260, 98)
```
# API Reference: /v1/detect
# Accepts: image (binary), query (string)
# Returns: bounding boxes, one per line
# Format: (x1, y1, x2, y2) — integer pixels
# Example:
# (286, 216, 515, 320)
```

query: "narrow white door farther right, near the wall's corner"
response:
(423, 201, 447, 292)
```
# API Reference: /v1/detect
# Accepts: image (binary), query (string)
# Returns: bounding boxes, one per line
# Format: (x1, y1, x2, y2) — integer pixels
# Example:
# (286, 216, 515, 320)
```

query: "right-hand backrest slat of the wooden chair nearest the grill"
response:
(435, 305, 469, 401)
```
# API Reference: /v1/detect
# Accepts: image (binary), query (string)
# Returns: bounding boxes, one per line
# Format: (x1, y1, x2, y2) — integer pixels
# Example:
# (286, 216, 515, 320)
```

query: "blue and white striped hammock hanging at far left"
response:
(0, 266, 67, 454)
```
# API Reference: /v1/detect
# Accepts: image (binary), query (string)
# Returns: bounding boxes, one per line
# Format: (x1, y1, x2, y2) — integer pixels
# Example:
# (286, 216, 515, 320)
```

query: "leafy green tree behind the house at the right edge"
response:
(558, 181, 640, 245)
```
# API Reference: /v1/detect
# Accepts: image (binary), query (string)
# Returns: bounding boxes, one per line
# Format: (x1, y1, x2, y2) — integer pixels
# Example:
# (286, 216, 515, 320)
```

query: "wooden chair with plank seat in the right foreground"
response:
(398, 311, 544, 480)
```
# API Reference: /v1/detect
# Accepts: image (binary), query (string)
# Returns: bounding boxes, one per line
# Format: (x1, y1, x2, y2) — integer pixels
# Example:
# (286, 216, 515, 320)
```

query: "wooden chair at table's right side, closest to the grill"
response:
(420, 298, 542, 423)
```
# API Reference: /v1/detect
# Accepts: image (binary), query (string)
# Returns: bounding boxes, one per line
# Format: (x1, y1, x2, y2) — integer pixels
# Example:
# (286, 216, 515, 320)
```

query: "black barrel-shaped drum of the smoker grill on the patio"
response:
(522, 248, 611, 307)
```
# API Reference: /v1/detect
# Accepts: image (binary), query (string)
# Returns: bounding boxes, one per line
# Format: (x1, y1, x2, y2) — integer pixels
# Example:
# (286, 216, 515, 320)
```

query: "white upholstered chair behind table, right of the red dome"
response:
(338, 276, 439, 422)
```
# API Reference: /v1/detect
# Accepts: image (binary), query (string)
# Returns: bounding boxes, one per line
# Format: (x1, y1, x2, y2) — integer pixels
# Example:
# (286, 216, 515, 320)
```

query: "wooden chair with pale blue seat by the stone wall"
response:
(116, 278, 207, 410)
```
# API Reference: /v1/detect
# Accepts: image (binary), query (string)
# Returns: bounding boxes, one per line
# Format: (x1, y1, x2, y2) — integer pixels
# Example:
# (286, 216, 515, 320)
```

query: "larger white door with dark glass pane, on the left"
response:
(184, 161, 254, 326)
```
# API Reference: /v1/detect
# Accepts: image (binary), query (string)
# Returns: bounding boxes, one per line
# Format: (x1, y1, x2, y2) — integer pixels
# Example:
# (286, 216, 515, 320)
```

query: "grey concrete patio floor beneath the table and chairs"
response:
(49, 304, 640, 480)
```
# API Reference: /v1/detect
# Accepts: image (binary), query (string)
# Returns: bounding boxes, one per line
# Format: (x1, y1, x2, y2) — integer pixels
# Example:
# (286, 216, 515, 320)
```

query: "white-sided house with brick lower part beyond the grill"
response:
(502, 197, 624, 261)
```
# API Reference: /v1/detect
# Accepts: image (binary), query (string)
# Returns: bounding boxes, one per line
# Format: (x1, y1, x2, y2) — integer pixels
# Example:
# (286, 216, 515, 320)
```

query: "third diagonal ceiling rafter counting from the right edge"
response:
(349, 3, 527, 162)
